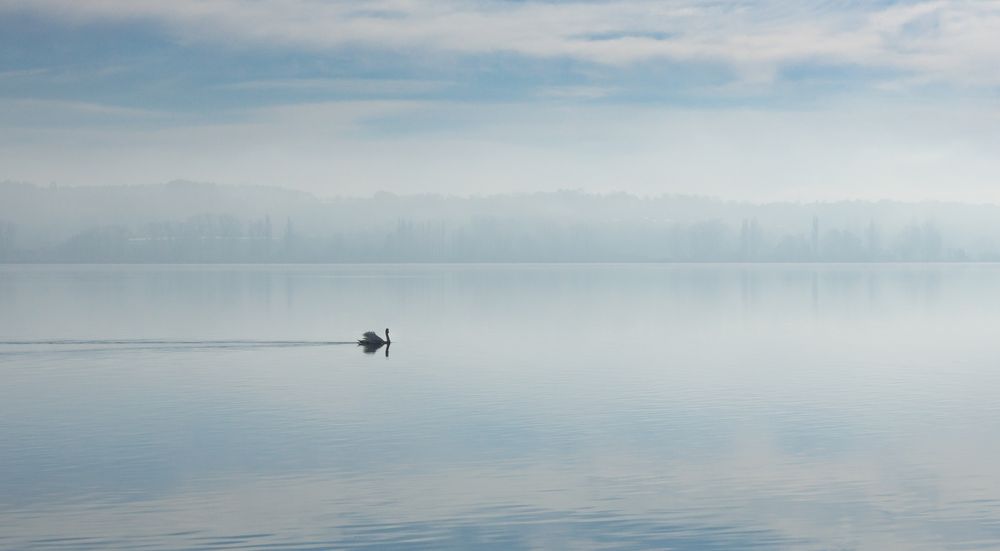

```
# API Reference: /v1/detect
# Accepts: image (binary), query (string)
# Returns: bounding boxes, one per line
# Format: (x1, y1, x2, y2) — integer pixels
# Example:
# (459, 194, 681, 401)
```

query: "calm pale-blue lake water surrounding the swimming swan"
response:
(0, 265, 1000, 550)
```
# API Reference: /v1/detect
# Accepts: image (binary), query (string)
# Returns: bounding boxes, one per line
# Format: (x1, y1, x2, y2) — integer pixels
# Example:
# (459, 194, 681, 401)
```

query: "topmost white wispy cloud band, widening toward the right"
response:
(7, 0, 1000, 85)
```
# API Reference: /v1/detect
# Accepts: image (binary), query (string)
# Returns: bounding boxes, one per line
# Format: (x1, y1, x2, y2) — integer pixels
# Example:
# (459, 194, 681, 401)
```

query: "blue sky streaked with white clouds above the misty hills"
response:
(0, 0, 1000, 203)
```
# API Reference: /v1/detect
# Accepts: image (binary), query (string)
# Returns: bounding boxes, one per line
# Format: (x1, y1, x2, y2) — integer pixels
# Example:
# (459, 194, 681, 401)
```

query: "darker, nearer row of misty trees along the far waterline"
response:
(0, 214, 976, 263)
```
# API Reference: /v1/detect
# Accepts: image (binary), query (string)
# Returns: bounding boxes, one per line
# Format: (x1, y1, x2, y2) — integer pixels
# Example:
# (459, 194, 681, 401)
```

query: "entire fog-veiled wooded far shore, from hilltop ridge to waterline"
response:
(0, 182, 1000, 263)
